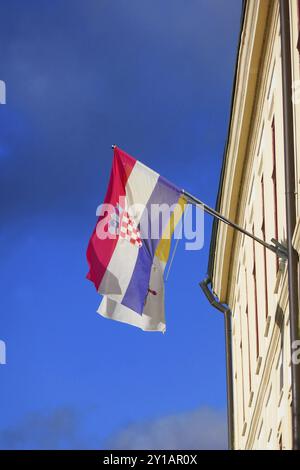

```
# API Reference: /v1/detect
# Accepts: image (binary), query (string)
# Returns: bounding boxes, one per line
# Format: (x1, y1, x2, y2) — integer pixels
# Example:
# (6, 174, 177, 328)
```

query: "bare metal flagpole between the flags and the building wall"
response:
(182, 189, 287, 259)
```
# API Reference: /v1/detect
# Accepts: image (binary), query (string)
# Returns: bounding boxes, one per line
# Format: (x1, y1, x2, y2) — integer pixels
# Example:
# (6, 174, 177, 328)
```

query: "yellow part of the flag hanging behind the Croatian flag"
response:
(155, 196, 187, 263)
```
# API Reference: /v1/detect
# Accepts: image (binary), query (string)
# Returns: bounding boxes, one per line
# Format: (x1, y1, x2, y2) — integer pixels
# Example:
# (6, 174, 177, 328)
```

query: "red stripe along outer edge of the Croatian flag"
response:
(86, 147, 136, 290)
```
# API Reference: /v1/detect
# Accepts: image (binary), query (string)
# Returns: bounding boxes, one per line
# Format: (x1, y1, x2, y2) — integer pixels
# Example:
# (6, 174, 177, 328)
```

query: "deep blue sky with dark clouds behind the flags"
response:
(0, 0, 241, 448)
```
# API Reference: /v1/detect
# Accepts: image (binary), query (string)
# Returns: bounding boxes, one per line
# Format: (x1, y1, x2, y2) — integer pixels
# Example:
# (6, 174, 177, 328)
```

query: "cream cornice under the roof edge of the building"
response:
(213, 0, 269, 302)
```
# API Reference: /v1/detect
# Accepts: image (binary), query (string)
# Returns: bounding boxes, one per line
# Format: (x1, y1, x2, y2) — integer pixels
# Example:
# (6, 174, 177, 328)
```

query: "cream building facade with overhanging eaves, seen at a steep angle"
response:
(209, 0, 300, 449)
